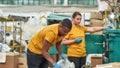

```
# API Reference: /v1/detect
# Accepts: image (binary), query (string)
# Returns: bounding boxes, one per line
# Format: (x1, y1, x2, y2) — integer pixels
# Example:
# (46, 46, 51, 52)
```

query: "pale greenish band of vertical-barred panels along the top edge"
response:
(0, 0, 97, 6)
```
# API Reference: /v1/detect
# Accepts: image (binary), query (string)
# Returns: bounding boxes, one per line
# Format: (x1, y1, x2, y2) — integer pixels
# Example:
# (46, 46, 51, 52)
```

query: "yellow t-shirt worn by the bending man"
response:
(28, 24, 63, 54)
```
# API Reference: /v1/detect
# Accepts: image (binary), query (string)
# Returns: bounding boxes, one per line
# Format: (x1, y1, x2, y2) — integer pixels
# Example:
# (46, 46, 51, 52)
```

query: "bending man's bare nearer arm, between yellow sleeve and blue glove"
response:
(42, 40, 55, 64)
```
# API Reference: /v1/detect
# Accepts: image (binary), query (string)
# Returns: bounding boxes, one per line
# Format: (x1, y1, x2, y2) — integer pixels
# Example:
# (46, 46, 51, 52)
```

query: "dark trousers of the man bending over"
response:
(27, 50, 48, 68)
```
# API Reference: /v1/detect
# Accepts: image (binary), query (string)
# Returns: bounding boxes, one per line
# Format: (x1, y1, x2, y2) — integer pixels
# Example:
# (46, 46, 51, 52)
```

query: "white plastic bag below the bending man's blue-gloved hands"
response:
(57, 59, 75, 68)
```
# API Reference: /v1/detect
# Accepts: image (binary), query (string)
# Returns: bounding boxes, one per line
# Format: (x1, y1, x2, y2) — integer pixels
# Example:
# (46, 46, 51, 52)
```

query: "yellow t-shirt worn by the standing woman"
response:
(65, 25, 87, 57)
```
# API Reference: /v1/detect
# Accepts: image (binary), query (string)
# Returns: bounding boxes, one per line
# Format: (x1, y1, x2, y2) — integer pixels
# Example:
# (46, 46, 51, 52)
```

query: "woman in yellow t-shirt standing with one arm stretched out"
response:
(61, 12, 109, 68)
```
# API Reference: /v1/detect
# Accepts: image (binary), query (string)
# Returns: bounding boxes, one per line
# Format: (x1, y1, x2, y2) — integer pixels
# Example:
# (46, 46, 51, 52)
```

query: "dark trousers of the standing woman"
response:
(68, 57, 86, 68)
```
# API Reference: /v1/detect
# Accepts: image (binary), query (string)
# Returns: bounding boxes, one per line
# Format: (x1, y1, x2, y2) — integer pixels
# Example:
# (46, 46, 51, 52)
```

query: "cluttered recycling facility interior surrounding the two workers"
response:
(0, 0, 120, 68)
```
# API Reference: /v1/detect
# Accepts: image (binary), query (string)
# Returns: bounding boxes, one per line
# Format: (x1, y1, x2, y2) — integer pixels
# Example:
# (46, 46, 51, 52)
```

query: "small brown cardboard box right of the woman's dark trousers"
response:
(91, 56, 103, 68)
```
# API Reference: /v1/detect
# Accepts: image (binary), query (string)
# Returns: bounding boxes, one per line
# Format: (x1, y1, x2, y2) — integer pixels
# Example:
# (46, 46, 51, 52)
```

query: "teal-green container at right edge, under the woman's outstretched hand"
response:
(106, 30, 120, 62)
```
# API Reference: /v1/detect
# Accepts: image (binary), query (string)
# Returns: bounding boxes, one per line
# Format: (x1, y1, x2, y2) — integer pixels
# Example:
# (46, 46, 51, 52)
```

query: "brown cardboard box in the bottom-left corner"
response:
(0, 53, 18, 68)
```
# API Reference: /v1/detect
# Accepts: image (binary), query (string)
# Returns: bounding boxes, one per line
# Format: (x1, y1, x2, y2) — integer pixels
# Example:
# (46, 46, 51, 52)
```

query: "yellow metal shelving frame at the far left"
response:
(0, 17, 23, 56)
